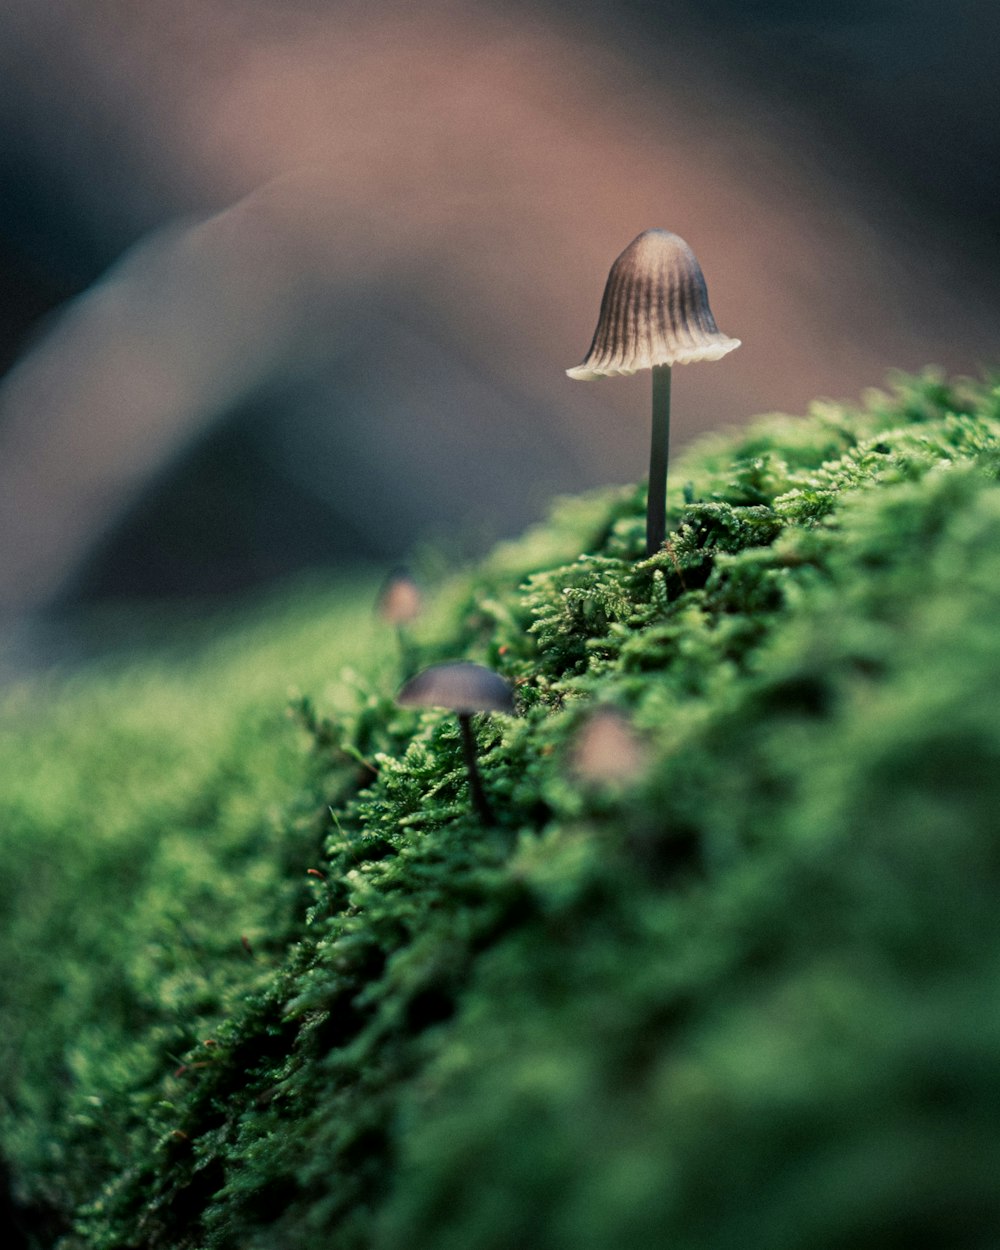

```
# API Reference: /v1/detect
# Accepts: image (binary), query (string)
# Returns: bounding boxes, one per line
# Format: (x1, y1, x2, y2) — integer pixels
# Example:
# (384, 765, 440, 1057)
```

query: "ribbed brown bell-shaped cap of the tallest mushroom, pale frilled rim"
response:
(566, 230, 740, 381)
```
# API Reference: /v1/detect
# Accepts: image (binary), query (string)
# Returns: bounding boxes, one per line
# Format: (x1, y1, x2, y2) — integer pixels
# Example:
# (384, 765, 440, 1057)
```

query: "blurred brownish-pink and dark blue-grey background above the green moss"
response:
(0, 0, 1000, 635)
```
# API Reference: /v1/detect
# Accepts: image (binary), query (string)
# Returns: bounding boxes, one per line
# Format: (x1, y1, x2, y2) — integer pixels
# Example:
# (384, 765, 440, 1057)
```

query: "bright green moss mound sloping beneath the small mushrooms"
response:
(0, 374, 1000, 1250)
